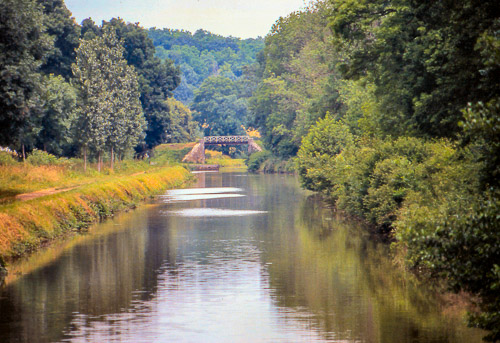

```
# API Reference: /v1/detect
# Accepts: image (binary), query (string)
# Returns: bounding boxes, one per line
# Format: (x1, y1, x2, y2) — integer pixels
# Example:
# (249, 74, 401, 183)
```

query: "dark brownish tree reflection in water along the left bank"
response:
(0, 211, 168, 342)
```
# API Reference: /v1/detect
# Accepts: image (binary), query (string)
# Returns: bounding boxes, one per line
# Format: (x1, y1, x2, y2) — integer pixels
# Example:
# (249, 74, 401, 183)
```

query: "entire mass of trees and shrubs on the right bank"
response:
(249, 0, 500, 341)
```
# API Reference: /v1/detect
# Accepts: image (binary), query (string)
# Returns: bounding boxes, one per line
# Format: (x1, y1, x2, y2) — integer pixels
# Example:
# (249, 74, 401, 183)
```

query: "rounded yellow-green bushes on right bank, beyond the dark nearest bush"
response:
(297, 129, 479, 229)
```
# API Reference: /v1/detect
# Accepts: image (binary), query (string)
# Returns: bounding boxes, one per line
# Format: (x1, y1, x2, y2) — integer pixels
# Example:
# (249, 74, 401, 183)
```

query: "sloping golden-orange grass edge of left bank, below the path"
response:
(0, 167, 192, 272)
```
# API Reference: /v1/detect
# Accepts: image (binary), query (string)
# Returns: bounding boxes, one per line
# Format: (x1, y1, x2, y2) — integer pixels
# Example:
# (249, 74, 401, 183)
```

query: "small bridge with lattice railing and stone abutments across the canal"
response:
(182, 136, 262, 163)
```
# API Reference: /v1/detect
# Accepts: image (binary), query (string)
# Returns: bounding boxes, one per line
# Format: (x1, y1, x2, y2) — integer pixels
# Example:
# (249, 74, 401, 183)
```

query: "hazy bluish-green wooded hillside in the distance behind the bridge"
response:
(149, 28, 264, 136)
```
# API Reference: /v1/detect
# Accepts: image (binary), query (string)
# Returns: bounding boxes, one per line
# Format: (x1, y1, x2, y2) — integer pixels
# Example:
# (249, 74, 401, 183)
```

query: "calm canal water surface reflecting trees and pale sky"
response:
(0, 173, 481, 343)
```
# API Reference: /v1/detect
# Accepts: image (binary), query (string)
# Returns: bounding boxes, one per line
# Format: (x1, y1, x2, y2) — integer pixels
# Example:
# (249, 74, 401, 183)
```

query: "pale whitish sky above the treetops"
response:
(65, 0, 306, 38)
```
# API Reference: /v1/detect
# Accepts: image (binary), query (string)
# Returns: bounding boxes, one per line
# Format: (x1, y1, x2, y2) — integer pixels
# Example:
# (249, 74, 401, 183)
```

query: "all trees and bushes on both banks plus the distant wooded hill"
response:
(0, 0, 500, 341)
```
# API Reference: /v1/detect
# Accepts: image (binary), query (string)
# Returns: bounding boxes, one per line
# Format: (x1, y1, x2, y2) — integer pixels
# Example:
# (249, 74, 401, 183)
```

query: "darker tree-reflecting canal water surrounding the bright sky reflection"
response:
(0, 174, 484, 343)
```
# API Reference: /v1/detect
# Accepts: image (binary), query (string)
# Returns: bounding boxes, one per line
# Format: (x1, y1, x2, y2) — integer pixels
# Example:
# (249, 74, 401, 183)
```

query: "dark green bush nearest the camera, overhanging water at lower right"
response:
(396, 191, 500, 342)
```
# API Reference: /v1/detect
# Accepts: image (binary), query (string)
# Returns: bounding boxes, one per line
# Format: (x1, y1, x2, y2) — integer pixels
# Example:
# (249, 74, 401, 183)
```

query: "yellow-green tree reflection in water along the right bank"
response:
(260, 186, 480, 342)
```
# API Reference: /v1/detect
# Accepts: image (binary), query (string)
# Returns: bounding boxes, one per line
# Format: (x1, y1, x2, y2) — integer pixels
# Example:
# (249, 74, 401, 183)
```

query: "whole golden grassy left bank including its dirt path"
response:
(0, 149, 193, 278)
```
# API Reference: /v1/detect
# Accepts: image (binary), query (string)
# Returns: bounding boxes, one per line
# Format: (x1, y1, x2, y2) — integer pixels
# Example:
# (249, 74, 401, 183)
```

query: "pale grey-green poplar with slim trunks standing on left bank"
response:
(73, 29, 145, 171)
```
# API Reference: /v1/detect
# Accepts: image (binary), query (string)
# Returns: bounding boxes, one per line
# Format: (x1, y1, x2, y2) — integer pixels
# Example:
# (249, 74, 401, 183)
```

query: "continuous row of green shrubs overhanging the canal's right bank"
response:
(296, 115, 500, 341)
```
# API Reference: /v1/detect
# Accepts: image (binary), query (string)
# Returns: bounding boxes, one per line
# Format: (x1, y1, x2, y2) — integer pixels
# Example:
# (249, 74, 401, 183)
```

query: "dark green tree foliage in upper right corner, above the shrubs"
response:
(330, 0, 499, 137)
